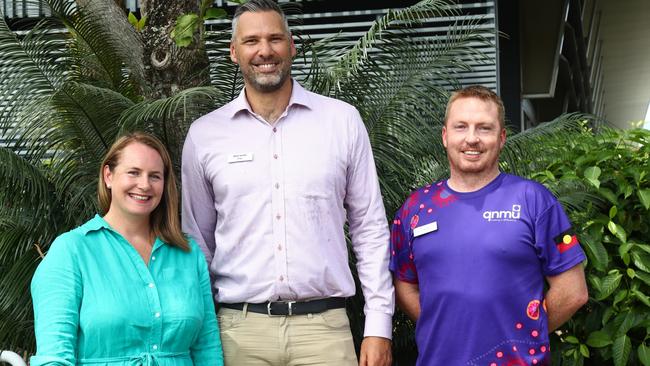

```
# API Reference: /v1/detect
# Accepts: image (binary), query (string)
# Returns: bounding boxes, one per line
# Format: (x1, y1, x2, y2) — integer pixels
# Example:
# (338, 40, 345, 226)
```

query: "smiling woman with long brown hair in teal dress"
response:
(31, 133, 223, 366)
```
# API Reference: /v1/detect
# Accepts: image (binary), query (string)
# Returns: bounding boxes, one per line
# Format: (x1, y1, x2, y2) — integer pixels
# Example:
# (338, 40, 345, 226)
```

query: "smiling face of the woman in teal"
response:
(104, 142, 165, 219)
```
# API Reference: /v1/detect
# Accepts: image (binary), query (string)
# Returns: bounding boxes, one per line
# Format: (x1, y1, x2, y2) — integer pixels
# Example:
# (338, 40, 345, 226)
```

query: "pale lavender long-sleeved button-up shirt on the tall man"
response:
(182, 81, 395, 339)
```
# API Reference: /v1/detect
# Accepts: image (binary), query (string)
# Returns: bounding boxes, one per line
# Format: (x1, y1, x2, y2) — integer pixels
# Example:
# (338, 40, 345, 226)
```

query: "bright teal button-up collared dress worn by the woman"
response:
(30, 216, 223, 366)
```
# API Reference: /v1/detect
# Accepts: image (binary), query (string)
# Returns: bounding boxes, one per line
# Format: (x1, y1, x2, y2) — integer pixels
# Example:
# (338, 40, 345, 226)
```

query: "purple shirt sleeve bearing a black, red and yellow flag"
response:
(535, 200, 585, 276)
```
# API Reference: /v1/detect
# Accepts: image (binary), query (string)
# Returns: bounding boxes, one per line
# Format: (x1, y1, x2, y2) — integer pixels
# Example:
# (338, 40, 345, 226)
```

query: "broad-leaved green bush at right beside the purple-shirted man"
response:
(529, 125, 650, 366)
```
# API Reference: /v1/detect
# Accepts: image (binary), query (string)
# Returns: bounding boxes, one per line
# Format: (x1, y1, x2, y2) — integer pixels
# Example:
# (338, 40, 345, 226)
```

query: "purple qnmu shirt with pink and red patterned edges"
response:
(390, 173, 585, 366)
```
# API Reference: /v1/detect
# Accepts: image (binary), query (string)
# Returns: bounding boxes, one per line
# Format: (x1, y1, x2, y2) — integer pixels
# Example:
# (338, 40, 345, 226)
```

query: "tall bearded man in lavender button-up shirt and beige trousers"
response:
(182, 0, 394, 366)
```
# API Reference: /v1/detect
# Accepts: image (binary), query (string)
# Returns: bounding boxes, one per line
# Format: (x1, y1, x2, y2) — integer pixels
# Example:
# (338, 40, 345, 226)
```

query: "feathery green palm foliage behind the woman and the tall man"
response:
(0, 0, 492, 352)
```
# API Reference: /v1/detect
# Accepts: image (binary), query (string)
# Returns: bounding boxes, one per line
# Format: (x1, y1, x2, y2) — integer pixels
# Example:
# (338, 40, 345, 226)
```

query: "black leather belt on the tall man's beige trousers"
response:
(219, 297, 345, 316)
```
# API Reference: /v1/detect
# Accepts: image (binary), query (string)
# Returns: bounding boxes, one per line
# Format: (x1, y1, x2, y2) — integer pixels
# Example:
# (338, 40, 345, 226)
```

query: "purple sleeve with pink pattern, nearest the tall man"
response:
(390, 204, 418, 284)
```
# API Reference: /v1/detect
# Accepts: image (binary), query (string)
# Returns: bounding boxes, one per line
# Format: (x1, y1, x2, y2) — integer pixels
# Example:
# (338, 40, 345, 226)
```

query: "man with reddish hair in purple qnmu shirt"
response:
(390, 86, 588, 366)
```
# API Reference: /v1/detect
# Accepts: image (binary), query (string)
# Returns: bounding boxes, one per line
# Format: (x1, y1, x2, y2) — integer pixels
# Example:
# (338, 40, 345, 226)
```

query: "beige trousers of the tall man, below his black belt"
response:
(218, 308, 358, 366)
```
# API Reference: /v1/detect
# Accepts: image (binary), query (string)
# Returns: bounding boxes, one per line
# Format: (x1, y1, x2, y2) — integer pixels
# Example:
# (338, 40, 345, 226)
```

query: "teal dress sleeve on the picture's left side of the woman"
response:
(30, 233, 83, 366)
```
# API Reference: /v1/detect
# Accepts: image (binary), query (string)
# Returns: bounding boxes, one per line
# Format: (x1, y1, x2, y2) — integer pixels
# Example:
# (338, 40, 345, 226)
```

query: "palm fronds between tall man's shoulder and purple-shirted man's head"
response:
(316, 23, 487, 212)
